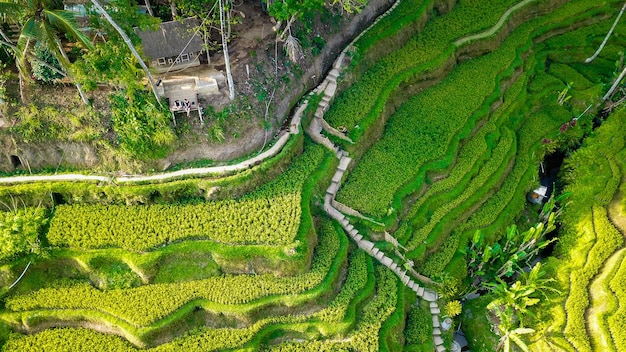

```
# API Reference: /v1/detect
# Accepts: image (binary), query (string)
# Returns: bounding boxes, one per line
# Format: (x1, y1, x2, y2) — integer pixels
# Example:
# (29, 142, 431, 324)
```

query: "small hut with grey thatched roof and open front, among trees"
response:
(135, 18, 202, 72)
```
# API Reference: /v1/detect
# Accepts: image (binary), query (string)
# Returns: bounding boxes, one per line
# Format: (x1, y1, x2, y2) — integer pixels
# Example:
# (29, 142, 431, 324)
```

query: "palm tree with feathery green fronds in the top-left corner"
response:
(0, 0, 93, 103)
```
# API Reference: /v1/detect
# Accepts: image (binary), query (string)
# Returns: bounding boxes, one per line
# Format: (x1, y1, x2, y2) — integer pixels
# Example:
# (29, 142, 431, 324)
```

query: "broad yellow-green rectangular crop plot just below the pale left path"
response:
(47, 142, 324, 251)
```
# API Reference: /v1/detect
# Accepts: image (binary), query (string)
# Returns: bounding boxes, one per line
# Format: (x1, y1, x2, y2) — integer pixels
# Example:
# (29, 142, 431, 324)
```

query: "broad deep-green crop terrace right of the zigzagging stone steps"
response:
(337, 28, 511, 217)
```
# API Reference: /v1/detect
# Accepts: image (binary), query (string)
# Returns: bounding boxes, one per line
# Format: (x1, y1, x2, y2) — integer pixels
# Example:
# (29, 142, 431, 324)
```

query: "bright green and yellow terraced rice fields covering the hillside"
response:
(0, 0, 626, 351)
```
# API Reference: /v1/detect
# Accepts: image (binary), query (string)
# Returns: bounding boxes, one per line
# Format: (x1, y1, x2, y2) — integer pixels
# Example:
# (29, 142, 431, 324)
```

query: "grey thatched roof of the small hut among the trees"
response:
(135, 18, 202, 59)
